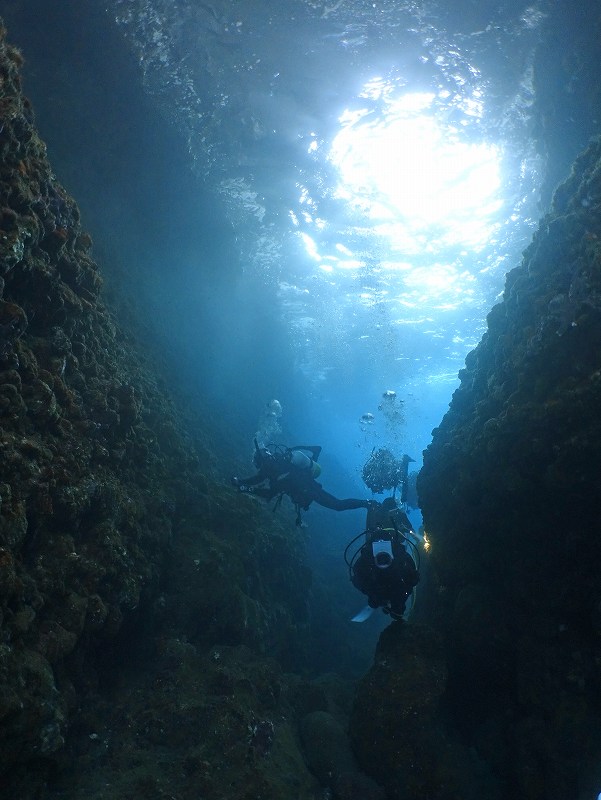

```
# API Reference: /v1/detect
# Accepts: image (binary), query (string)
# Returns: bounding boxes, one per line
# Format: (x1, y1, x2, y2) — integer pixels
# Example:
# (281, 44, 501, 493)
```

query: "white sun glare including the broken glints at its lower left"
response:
(291, 86, 503, 312)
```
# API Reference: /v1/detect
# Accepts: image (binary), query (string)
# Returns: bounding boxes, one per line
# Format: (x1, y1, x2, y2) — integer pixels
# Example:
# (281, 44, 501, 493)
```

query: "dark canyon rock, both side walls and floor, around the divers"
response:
(0, 3, 601, 800)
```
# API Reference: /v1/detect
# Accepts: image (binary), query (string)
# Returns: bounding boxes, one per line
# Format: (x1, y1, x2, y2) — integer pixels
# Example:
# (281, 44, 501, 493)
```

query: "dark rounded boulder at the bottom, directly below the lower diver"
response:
(350, 622, 497, 800)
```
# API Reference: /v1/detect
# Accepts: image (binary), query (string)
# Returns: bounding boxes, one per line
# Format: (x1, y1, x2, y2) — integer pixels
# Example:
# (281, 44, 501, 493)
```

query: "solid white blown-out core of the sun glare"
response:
(331, 93, 500, 251)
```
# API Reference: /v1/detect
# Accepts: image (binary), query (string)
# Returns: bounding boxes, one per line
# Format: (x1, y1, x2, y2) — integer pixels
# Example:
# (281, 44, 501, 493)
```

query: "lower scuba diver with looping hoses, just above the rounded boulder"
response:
(344, 497, 419, 622)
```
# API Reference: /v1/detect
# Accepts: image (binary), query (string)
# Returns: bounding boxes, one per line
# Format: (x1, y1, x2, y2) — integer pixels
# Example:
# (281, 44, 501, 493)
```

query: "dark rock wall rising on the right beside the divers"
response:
(418, 139, 601, 800)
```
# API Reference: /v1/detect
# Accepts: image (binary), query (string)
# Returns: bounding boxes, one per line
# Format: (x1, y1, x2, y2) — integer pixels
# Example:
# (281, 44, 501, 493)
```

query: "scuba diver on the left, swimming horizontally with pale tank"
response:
(232, 439, 369, 525)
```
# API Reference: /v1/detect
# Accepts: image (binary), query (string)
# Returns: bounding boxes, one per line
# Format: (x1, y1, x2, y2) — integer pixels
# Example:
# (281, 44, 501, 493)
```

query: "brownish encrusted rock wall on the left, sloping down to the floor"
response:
(0, 21, 315, 798)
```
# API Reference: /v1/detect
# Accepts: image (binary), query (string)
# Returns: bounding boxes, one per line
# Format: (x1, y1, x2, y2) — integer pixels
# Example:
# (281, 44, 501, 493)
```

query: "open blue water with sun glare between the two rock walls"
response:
(7, 0, 545, 527)
